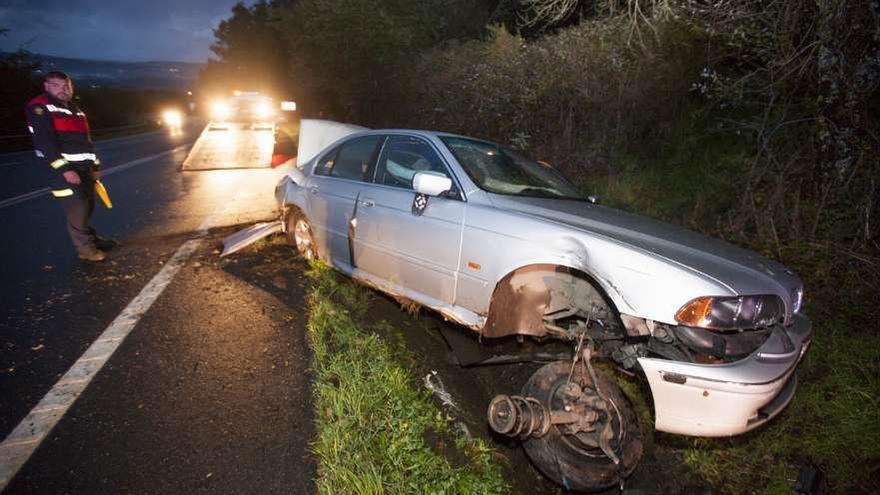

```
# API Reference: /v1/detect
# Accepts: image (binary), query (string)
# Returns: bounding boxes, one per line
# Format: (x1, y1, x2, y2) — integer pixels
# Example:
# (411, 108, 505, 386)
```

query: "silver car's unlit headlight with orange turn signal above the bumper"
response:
(675, 296, 785, 330)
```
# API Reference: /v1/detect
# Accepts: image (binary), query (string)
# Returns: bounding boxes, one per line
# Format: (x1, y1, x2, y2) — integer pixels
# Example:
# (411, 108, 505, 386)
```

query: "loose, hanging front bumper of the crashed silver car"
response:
(639, 315, 812, 437)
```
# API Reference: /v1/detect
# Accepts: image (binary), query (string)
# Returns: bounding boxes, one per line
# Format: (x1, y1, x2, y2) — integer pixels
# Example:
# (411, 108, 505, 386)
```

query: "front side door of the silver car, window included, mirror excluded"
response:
(353, 135, 467, 304)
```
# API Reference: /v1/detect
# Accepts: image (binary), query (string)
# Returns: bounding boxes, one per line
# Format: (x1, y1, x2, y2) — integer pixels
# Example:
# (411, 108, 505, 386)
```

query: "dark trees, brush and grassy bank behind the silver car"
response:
(206, 0, 880, 493)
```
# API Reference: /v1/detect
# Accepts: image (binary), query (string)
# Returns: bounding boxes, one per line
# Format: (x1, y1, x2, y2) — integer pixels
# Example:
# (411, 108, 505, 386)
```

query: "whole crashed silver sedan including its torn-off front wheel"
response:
(276, 120, 811, 490)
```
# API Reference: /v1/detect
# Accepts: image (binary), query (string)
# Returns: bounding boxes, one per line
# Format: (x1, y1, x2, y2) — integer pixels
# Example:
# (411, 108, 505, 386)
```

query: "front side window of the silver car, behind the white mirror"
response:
(376, 136, 451, 189)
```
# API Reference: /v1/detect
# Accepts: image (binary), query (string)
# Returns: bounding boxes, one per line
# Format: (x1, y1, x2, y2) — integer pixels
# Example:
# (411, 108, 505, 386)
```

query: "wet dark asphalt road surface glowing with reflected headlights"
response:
(0, 128, 315, 494)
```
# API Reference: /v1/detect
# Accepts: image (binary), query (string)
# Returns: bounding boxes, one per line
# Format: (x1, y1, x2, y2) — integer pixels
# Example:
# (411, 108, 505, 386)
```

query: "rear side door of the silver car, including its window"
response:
(307, 135, 384, 268)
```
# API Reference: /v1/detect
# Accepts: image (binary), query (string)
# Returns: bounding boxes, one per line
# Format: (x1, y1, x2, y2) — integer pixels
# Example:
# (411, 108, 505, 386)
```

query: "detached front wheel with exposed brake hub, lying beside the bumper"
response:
(522, 362, 642, 491)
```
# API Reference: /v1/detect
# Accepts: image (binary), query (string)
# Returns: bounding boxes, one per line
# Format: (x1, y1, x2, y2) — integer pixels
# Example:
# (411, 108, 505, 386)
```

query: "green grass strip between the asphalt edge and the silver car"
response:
(308, 264, 509, 494)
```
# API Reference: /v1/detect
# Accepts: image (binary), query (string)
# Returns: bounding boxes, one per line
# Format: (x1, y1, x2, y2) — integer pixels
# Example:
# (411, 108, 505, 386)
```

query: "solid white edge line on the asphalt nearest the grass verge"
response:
(0, 176, 237, 492)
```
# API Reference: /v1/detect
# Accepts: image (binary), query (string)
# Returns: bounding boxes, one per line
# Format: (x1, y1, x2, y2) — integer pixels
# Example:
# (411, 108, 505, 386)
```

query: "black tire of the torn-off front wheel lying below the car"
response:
(522, 361, 642, 491)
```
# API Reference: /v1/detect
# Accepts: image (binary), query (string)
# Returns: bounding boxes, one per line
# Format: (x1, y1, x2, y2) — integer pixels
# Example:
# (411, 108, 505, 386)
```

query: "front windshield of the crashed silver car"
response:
(441, 136, 584, 200)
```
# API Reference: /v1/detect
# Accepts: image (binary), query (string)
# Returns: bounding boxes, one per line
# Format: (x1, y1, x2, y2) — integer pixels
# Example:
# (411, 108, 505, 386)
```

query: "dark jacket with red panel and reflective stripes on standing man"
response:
(25, 93, 100, 186)
